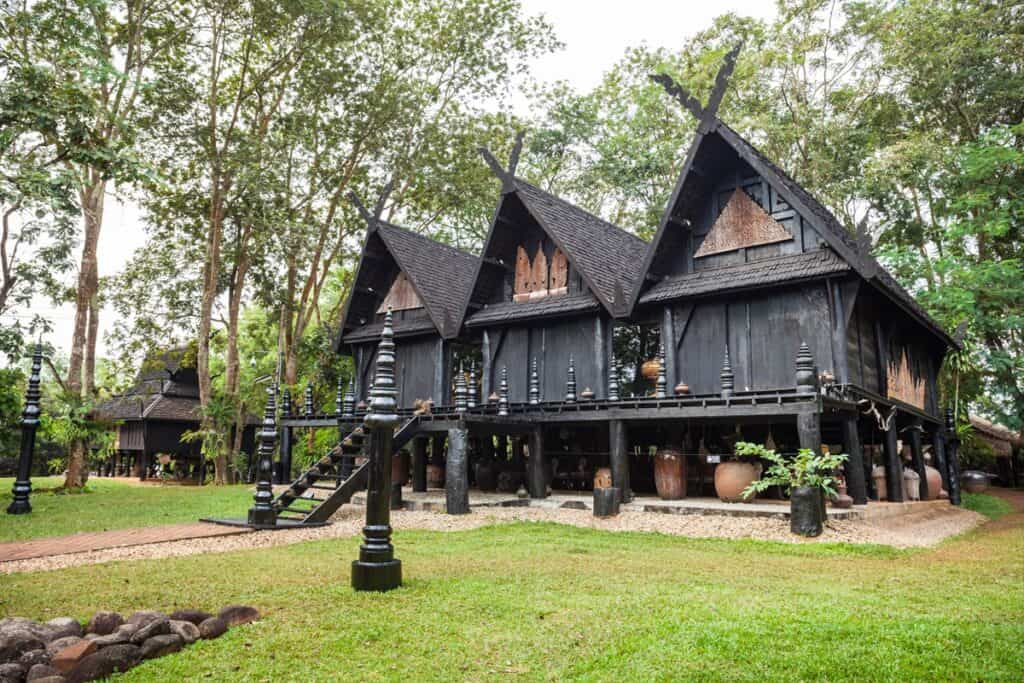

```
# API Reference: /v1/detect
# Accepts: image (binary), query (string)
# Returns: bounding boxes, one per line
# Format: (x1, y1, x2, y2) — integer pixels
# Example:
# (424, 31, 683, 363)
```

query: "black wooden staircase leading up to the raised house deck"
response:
(273, 416, 419, 524)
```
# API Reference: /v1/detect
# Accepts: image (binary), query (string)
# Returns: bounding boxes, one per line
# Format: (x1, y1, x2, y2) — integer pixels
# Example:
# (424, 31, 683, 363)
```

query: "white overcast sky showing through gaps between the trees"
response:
(24, 0, 775, 356)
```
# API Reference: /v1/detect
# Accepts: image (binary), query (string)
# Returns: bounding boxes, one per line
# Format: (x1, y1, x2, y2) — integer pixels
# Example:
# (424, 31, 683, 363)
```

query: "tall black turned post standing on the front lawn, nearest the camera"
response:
(352, 308, 401, 591)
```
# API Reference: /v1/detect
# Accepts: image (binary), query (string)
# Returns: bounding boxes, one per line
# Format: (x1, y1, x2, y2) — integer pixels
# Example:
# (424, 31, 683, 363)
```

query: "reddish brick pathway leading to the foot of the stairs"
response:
(0, 522, 252, 562)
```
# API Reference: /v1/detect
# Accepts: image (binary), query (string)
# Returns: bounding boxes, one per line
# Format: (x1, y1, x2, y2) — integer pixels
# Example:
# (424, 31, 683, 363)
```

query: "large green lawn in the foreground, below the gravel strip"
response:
(0, 485, 1024, 681)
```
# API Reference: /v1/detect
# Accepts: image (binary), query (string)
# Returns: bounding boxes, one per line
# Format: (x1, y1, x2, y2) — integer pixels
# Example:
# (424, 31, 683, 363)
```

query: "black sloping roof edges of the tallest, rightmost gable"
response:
(631, 119, 959, 347)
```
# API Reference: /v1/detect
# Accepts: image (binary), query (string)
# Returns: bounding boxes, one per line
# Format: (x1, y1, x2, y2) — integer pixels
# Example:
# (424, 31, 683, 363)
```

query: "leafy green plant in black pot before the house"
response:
(736, 441, 847, 536)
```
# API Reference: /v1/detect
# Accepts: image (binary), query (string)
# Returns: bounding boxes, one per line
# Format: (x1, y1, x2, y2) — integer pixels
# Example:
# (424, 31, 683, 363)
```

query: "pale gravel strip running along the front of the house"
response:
(0, 505, 984, 573)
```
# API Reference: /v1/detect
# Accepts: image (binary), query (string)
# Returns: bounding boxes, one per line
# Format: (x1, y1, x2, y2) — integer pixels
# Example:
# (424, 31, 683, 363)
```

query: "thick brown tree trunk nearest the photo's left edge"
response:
(65, 173, 106, 488)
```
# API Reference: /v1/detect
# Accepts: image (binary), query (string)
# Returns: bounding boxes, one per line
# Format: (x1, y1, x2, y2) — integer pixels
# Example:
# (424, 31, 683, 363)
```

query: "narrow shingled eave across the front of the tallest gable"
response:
(640, 249, 850, 304)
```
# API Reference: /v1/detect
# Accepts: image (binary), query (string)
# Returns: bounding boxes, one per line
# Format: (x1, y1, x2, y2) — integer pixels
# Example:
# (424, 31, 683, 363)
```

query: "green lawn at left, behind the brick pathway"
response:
(0, 477, 252, 543)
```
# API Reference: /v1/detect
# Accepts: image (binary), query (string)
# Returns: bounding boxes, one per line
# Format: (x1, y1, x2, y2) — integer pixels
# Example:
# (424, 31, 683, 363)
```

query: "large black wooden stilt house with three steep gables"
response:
(284, 77, 956, 519)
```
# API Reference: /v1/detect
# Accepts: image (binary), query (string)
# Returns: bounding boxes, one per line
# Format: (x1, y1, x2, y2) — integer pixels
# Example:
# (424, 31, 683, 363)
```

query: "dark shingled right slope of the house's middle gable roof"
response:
(515, 178, 647, 312)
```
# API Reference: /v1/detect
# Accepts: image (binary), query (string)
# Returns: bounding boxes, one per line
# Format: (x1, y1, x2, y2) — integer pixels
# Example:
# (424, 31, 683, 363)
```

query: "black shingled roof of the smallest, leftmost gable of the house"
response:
(338, 219, 477, 345)
